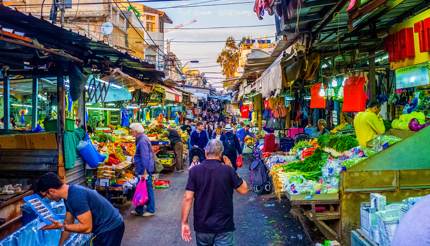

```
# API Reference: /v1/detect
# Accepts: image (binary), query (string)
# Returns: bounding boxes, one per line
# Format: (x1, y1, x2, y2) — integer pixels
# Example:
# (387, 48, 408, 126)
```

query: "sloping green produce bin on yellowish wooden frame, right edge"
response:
(339, 127, 430, 245)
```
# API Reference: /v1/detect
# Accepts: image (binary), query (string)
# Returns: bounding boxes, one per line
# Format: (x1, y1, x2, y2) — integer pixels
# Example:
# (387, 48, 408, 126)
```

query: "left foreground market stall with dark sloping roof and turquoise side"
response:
(0, 5, 161, 242)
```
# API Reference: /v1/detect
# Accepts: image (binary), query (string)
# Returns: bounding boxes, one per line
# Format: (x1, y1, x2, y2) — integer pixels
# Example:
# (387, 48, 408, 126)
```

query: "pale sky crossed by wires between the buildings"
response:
(145, 0, 275, 90)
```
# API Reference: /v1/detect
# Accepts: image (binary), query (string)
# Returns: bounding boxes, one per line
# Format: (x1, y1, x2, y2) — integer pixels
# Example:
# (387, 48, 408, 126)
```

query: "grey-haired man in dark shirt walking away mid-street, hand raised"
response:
(182, 139, 248, 246)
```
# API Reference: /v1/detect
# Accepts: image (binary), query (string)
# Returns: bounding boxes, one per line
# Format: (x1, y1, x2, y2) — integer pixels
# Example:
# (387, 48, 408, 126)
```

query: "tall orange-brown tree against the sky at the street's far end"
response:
(216, 37, 240, 80)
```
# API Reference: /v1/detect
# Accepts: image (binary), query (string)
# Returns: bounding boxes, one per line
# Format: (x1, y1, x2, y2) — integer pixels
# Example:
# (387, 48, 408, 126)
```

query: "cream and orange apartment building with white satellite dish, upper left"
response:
(8, 0, 172, 65)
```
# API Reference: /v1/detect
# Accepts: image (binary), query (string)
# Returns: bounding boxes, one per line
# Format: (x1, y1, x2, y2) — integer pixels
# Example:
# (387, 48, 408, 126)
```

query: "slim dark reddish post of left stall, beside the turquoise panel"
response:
(57, 73, 66, 181)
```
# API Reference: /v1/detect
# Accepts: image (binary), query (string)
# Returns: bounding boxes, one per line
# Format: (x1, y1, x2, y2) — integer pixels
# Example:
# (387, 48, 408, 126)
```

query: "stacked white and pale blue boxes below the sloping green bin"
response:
(360, 193, 420, 246)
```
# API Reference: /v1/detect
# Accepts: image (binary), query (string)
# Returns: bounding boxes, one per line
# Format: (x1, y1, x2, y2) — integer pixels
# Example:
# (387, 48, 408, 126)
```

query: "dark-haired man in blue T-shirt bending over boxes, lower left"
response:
(35, 173, 124, 246)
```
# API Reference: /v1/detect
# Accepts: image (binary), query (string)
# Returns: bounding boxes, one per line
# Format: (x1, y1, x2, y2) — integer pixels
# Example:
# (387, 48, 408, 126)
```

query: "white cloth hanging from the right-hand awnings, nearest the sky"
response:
(255, 54, 282, 98)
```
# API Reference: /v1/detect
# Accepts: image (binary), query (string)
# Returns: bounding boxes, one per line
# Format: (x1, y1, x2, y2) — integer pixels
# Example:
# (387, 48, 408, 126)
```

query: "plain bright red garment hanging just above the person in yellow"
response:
(342, 77, 367, 112)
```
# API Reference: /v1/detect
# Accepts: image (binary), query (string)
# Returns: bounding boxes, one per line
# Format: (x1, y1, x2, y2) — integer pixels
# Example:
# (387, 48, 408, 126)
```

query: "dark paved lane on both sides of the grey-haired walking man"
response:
(123, 165, 311, 246)
